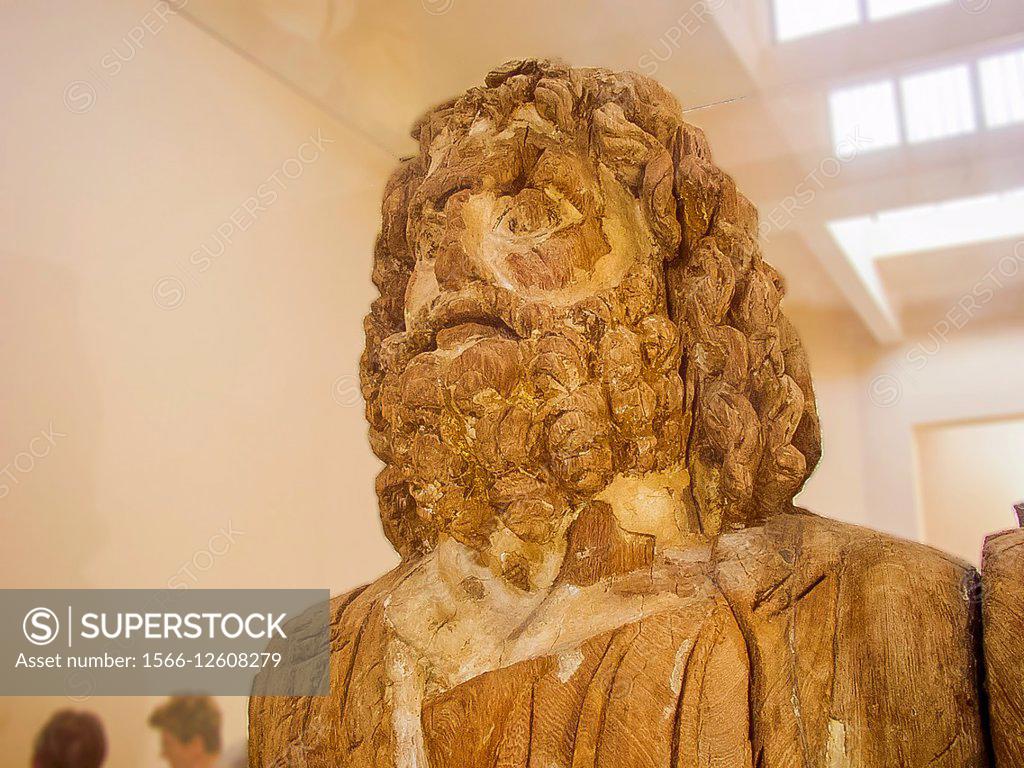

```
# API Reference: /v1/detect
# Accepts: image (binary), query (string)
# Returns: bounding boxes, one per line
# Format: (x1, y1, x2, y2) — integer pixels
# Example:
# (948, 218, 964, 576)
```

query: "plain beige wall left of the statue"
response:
(0, 0, 396, 768)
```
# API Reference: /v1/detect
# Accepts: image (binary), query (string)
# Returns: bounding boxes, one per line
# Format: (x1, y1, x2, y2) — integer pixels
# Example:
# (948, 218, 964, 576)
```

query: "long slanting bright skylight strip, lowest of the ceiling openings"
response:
(828, 187, 1024, 263)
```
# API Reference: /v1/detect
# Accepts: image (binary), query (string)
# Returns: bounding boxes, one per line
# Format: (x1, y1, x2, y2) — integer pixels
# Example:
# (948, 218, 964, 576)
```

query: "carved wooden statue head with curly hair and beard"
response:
(361, 60, 820, 556)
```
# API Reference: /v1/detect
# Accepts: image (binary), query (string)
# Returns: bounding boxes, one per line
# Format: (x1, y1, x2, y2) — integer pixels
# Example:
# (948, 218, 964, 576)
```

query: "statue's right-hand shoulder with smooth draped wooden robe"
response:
(714, 511, 984, 766)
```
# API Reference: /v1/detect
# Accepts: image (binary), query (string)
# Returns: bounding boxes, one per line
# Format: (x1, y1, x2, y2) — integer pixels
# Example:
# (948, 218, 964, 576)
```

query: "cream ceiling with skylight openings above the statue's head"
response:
(184, 0, 1024, 342)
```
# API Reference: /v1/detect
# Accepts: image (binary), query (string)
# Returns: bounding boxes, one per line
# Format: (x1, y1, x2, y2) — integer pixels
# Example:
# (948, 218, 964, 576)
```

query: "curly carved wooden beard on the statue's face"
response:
(370, 297, 685, 551)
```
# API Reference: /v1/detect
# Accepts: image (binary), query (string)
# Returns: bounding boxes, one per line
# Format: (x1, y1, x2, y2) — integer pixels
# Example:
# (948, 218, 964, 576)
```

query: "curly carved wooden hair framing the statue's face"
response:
(360, 59, 820, 556)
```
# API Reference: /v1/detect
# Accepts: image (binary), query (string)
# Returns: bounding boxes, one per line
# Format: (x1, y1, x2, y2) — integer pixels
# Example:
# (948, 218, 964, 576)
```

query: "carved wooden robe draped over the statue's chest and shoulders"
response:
(250, 517, 988, 768)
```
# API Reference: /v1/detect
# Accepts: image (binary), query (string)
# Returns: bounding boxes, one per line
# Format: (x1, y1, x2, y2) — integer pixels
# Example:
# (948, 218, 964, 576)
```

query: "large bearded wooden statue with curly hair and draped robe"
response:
(250, 60, 1024, 768)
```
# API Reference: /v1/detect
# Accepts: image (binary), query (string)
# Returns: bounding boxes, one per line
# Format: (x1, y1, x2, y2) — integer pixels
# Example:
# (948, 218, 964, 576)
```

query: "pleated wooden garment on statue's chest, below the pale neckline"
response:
(423, 610, 752, 768)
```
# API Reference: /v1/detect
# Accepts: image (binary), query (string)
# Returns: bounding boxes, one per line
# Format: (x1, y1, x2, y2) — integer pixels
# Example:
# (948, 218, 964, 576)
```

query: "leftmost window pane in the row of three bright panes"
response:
(828, 80, 900, 152)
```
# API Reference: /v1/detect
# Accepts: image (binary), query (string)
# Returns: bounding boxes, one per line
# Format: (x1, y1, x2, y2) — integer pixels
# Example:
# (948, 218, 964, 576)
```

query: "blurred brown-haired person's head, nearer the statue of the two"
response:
(150, 695, 220, 768)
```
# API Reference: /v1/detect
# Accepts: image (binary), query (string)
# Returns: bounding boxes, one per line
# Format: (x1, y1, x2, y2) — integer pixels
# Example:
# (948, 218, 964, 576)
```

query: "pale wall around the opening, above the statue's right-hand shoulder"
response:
(793, 311, 1024, 559)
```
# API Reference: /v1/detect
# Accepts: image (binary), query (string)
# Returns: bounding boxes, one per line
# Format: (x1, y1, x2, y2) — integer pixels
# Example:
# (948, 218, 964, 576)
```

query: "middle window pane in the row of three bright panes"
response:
(900, 65, 975, 144)
